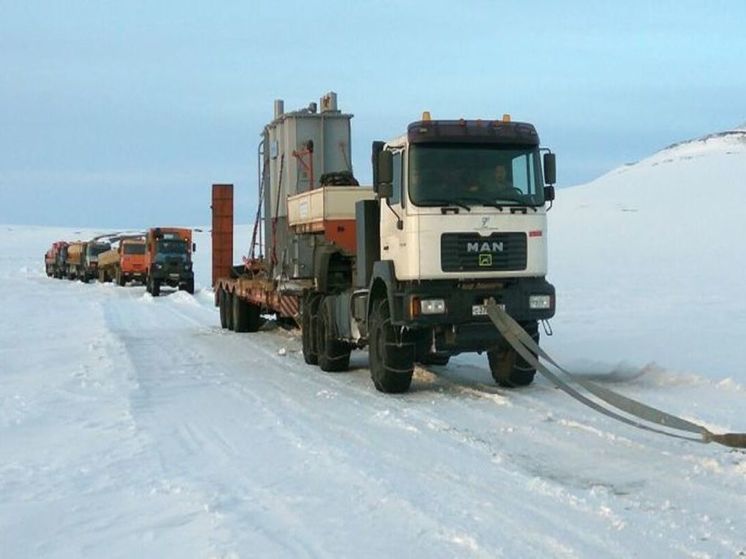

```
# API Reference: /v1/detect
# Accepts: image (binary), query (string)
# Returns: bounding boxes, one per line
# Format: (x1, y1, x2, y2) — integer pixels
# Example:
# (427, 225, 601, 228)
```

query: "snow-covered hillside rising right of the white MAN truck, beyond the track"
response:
(550, 126, 746, 382)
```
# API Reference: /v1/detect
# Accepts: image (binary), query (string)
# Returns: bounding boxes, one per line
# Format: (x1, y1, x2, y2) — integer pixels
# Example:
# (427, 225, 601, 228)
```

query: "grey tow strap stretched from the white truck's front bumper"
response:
(485, 299, 746, 448)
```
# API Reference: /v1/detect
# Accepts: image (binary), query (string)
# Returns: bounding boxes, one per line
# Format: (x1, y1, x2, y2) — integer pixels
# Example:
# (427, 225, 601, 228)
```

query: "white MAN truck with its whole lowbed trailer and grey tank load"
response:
(213, 93, 555, 393)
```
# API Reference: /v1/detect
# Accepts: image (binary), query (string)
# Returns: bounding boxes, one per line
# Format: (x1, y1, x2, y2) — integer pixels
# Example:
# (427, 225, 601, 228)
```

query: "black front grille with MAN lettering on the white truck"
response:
(440, 233, 527, 272)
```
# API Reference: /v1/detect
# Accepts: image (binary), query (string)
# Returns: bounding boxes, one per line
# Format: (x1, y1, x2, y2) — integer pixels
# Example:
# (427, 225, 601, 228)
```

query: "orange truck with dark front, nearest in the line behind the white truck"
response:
(145, 227, 197, 297)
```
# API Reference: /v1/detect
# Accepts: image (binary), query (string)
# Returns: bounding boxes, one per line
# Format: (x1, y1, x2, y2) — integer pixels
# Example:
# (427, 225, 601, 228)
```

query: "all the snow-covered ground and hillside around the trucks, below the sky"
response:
(0, 129, 746, 558)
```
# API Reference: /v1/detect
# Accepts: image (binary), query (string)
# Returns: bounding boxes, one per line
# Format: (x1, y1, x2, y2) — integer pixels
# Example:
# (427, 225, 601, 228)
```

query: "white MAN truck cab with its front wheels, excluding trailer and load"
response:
(353, 115, 555, 392)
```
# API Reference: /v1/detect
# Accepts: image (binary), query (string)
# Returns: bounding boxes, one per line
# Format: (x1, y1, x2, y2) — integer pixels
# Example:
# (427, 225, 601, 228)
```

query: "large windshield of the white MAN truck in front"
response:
(409, 144, 544, 206)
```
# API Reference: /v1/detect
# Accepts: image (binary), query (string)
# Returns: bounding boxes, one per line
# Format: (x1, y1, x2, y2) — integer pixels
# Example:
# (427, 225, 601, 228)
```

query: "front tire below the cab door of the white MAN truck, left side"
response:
(368, 298, 414, 394)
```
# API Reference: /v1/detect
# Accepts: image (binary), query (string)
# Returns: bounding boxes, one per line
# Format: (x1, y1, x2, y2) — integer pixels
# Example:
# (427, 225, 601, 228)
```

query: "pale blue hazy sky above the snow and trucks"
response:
(0, 0, 746, 227)
